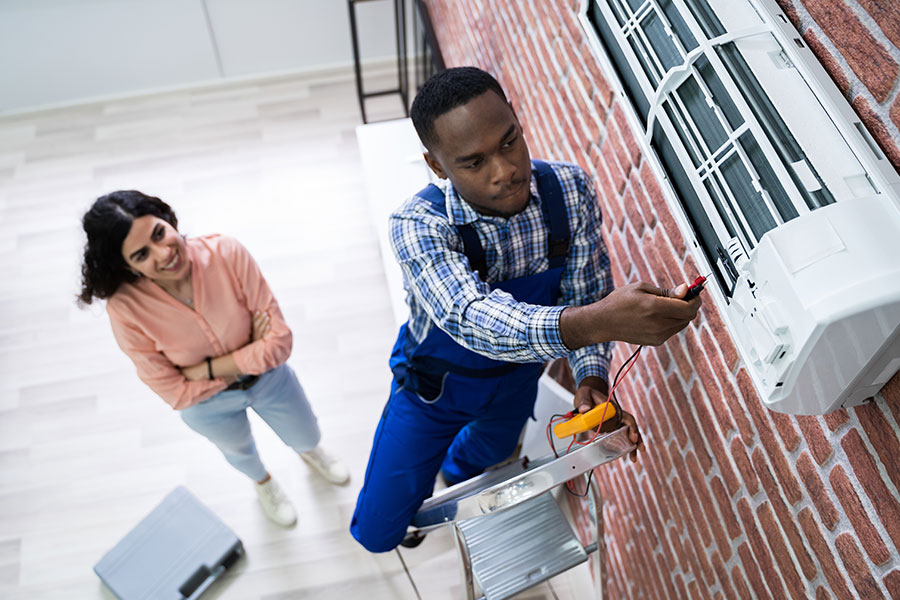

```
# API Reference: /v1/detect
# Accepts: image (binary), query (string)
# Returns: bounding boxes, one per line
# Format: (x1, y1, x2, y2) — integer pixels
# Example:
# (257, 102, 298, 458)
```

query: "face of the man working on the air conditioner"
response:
(425, 90, 531, 217)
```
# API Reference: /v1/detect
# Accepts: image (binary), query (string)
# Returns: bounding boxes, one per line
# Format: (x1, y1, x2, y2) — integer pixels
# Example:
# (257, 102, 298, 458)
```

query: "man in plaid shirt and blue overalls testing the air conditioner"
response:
(350, 67, 700, 552)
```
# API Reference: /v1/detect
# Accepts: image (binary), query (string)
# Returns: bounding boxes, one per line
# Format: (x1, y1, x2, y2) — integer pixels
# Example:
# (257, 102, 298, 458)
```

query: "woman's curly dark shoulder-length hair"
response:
(78, 190, 178, 306)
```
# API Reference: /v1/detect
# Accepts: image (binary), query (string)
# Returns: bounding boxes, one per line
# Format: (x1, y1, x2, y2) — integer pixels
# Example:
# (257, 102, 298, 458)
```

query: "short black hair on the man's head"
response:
(409, 67, 509, 149)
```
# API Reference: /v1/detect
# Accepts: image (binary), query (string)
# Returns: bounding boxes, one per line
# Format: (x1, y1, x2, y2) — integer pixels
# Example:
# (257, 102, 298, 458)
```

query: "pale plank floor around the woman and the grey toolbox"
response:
(0, 71, 588, 600)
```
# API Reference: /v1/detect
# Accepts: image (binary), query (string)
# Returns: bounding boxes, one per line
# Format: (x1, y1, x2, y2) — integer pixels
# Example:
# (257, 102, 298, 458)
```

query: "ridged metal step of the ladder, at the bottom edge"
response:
(457, 492, 587, 600)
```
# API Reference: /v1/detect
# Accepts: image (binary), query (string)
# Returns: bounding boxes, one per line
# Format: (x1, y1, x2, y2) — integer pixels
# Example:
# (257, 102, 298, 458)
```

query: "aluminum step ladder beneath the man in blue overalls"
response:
(411, 427, 634, 600)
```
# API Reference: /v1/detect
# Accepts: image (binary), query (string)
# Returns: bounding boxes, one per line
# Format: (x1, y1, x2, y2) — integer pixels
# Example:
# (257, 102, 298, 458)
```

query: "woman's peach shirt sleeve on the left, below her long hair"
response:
(106, 302, 225, 410)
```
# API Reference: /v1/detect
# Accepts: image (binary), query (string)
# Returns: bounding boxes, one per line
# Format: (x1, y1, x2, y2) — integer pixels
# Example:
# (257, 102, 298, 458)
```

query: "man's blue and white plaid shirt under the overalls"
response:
(390, 162, 613, 382)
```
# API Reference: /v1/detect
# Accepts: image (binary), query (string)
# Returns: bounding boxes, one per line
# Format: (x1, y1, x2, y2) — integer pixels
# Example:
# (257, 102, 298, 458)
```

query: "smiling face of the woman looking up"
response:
(122, 215, 191, 281)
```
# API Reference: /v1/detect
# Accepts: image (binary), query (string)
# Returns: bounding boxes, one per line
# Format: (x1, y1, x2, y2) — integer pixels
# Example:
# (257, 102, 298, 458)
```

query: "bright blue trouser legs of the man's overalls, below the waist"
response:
(350, 365, 541, 552)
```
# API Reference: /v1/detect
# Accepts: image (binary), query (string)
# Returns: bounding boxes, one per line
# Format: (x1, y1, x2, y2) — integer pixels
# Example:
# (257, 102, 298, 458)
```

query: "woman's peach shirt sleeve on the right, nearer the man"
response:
(222, 238, 293, 375)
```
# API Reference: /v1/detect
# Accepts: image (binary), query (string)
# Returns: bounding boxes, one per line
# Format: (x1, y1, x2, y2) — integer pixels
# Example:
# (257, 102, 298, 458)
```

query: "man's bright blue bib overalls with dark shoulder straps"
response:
(350, 161, 569, 552)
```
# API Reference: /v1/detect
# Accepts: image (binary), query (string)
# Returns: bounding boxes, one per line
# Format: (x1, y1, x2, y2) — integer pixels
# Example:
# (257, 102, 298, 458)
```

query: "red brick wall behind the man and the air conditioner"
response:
(428, 0, 900, 599)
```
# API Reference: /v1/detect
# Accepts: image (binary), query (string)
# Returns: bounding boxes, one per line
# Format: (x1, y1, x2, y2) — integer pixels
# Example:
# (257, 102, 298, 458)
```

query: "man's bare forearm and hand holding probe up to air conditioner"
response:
(559, 283, 703, 349)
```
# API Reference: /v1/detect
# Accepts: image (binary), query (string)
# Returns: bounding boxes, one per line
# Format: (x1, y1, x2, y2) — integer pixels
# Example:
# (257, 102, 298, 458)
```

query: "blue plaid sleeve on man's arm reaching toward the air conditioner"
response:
(390, 209, 569, 362)
